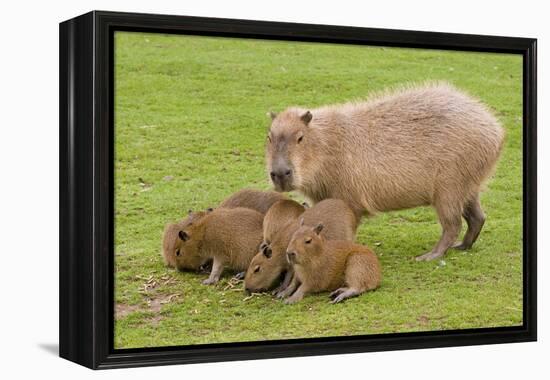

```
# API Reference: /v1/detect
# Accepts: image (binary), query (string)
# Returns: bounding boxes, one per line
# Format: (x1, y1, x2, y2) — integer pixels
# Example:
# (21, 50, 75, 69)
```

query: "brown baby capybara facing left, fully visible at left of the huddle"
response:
(175, 207, 264, 285)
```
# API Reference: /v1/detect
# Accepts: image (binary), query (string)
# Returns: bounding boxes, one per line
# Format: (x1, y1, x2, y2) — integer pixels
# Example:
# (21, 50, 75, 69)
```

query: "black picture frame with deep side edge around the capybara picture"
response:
(59, 11, 537, 369)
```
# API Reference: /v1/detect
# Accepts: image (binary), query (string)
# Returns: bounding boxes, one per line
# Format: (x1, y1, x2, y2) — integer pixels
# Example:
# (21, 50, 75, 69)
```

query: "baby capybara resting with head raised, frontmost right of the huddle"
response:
(285, 224, 382, 304)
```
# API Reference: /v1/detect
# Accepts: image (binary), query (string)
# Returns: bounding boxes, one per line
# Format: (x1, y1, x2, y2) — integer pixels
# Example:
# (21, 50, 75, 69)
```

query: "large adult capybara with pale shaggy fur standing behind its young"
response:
(266, 83, 504, 260)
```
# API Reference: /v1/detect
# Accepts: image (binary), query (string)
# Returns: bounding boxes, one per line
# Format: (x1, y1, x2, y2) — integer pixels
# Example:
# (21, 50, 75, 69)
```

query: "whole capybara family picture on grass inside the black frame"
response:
(114, 31, 523, 349)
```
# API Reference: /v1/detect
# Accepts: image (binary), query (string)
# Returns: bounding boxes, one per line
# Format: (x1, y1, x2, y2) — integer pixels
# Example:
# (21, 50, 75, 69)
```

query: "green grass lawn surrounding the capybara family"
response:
(115, 32, 522, 348)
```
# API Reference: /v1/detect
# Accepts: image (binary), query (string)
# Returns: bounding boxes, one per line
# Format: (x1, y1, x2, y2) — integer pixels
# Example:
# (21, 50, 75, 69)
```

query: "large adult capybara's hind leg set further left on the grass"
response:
(416, 196, 462, 261)
